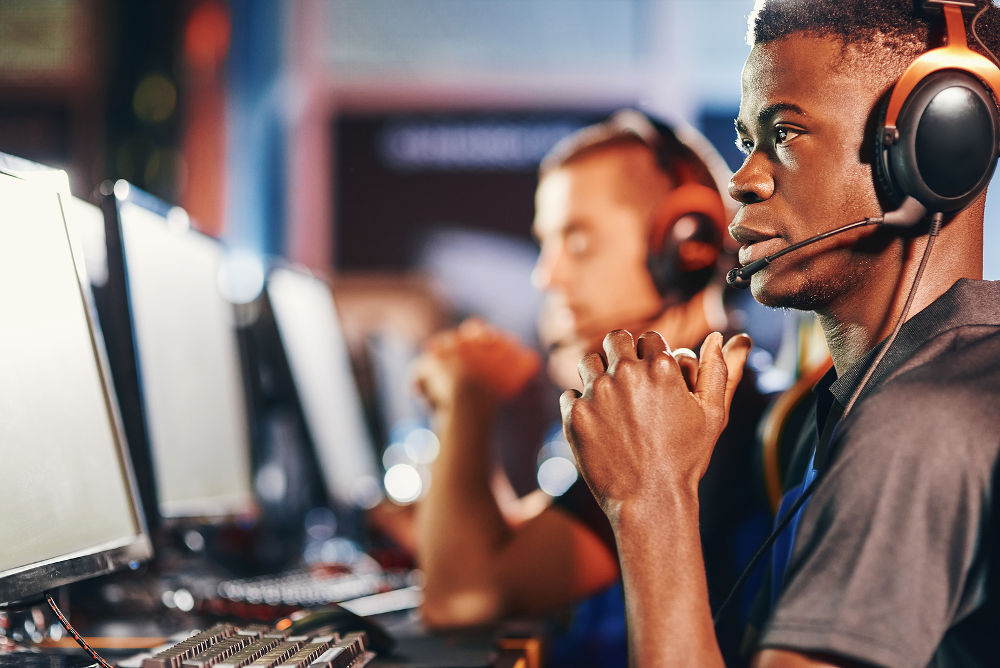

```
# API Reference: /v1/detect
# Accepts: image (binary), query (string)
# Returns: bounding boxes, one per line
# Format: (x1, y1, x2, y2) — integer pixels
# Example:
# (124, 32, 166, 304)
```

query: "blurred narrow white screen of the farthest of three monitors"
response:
(267, 268, 381, 506)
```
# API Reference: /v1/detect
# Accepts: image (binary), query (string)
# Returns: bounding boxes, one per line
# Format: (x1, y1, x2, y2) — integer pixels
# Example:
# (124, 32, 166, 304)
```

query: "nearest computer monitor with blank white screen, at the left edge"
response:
(0, 171, 152, 605)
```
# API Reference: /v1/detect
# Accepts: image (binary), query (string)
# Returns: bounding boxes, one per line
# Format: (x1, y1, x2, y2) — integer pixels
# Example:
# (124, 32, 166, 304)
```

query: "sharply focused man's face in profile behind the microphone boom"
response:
(730, 33, 901, 311)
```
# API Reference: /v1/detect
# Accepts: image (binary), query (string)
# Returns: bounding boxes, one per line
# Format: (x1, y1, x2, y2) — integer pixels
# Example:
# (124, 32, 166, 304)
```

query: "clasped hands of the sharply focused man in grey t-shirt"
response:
(560, 330, 750, 524)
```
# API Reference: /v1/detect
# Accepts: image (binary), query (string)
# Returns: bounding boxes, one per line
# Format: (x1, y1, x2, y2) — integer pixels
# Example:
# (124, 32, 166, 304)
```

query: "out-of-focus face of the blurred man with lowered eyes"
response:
(533, 147, 661, 342)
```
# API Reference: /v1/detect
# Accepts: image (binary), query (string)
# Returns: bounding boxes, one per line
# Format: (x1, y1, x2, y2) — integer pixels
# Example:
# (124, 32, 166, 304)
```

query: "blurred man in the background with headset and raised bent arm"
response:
(417, 111, 767, 663)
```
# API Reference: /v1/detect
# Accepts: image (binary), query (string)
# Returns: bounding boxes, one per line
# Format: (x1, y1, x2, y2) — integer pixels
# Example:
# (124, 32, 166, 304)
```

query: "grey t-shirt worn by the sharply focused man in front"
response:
(759, 280, 1000, 666)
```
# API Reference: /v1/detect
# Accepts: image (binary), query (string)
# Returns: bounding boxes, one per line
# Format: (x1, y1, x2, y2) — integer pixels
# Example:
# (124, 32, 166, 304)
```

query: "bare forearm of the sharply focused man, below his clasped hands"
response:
(612, 489, 723, 668)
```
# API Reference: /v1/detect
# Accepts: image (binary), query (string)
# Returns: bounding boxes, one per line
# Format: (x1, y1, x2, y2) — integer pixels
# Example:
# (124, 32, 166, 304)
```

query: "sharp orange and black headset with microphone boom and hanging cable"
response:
(715, 0, 1000, 623)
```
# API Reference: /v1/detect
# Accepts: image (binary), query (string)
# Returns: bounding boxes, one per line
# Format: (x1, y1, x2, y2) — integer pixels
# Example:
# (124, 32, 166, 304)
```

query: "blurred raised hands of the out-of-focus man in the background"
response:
(414, 319, 541, 409)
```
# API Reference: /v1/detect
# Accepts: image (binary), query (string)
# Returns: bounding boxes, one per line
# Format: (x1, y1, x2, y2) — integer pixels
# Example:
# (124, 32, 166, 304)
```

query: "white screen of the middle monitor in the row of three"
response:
(109, 187, 254, 520)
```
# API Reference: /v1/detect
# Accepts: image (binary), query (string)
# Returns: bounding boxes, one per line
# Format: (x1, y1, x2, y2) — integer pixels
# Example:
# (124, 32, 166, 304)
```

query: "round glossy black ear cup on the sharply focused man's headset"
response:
(876, 69, 1000, 213)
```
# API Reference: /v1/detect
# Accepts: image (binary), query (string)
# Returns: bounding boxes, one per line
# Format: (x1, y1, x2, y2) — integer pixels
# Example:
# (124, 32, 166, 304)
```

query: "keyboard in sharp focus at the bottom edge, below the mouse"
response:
(124, 623, 375, 668)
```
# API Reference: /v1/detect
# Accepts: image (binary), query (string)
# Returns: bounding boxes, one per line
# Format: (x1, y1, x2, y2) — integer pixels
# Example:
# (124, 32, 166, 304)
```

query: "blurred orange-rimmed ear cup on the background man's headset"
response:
(646, 184, 726, 302)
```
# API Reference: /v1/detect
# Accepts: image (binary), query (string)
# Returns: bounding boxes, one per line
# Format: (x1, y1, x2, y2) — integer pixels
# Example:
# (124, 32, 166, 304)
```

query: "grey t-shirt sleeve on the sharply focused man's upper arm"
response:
(760, 383, 996, 666)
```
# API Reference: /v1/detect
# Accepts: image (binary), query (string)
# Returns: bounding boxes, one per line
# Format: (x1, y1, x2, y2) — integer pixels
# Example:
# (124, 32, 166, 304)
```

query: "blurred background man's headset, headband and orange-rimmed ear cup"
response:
(596, 109, 728, 304)
